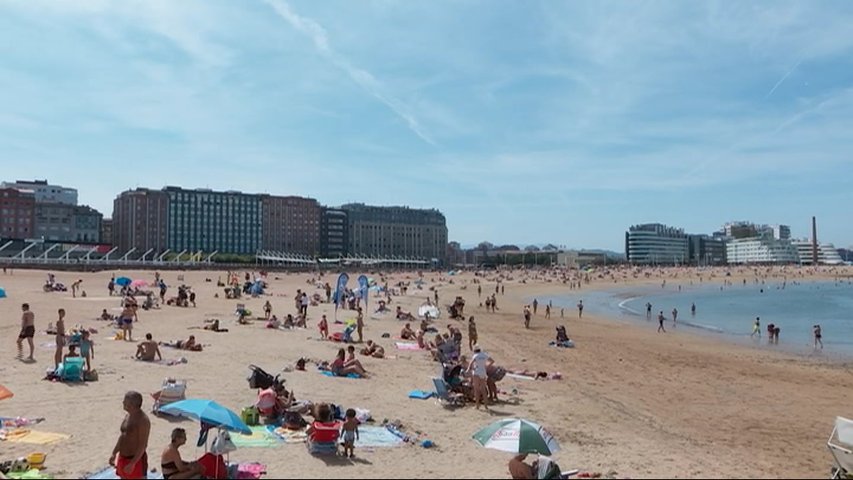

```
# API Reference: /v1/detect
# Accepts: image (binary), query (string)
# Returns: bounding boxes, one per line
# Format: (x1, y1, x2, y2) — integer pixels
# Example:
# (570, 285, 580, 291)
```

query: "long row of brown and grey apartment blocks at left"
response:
(0, 180, 447, 262)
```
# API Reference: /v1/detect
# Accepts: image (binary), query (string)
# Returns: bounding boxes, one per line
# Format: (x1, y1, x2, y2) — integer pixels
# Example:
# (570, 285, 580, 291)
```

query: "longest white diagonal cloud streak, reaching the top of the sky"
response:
(266, 0, 436, 146)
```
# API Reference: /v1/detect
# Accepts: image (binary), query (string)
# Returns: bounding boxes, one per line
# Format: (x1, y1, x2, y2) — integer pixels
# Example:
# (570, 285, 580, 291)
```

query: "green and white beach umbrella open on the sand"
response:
(472, 418, 560, 455)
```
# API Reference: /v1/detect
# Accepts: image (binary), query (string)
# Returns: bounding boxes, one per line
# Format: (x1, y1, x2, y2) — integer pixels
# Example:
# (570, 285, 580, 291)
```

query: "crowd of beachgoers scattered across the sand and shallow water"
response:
(8, 267, 852, 478)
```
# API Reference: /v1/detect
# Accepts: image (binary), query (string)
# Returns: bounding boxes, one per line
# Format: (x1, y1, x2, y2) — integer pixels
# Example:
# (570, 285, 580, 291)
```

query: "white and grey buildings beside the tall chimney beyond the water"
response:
(625, 219, 845, 265)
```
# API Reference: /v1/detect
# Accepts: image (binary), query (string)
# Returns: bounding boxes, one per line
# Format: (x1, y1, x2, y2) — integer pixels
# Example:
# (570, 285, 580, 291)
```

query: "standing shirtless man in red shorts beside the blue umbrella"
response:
(109, 391, 151, 478)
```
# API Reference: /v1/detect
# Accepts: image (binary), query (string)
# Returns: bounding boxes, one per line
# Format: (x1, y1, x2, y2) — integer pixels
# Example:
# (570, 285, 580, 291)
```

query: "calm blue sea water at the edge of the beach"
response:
(530, 280, 853, 356)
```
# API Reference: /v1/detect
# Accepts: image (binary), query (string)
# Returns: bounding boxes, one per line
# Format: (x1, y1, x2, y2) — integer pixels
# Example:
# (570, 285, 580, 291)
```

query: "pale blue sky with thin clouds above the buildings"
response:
(0, 0, 853, 250)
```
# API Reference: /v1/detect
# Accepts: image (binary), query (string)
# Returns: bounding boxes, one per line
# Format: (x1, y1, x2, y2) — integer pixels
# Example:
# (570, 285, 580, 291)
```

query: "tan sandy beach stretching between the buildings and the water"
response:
(0, 269, 853, 478)
